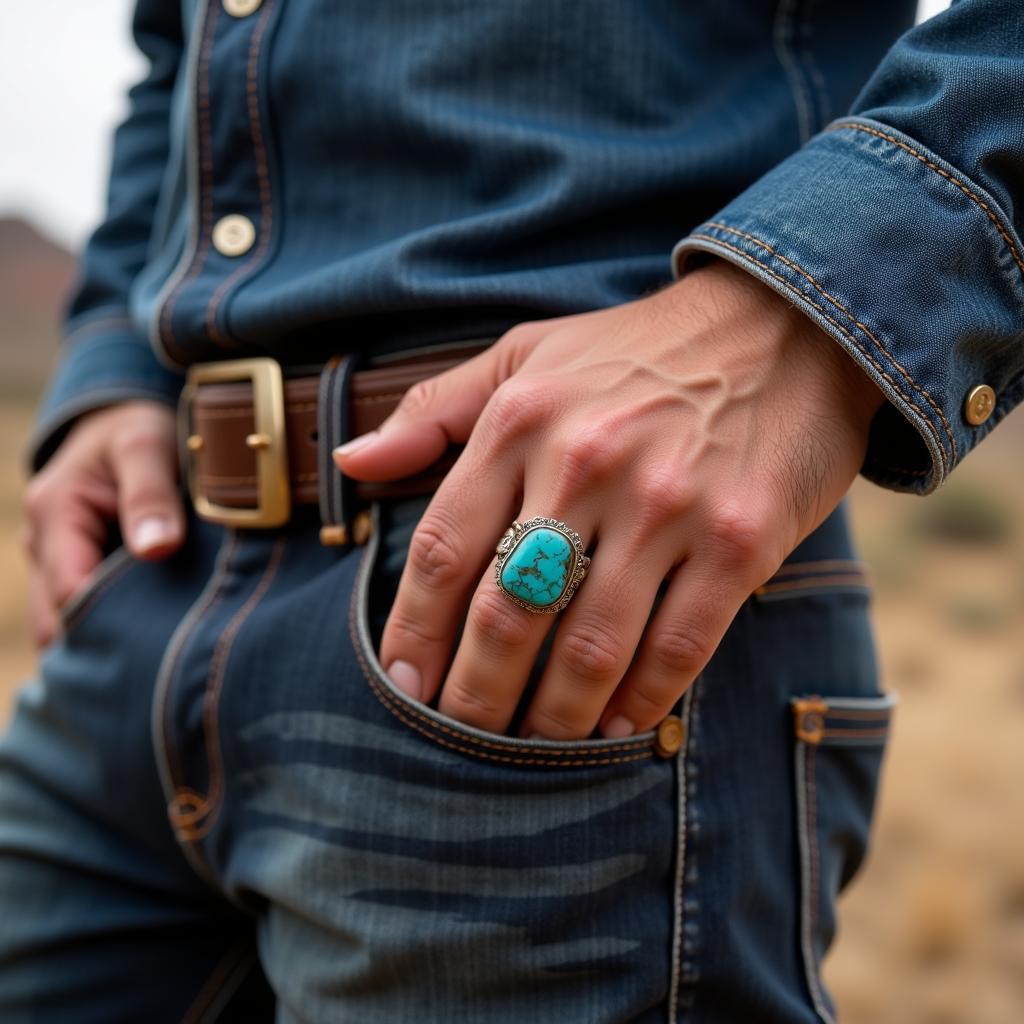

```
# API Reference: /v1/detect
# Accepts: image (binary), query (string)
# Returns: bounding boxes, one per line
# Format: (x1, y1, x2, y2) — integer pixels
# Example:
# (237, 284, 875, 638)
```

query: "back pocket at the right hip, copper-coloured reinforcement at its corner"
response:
(792, 694, 896, 1024)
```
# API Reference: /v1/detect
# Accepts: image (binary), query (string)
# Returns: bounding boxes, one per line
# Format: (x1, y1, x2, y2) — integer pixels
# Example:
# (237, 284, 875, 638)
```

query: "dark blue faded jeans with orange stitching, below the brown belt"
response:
(0, 491, 891, 1024)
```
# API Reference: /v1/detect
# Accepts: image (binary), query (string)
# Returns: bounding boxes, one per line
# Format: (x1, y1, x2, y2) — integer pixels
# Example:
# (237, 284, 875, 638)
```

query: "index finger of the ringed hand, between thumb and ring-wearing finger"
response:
(381, 442, 522, 701)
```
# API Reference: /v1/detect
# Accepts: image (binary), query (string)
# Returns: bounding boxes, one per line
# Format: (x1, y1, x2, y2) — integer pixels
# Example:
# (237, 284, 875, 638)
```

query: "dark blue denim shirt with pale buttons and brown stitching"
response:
(32, 0, 1024, 493)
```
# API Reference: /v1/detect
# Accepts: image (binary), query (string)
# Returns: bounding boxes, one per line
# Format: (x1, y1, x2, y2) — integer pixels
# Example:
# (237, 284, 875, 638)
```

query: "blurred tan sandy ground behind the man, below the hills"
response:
(0, 393, 1024, 1024)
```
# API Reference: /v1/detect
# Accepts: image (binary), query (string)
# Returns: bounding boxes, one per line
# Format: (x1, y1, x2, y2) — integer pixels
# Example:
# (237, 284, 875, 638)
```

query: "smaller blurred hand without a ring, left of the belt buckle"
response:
(26, 401, 185, 646)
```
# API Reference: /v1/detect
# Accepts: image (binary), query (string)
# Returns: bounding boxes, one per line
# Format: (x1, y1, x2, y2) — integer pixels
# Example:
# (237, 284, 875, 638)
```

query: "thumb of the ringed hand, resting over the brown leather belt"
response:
(334, 325, 535, 480)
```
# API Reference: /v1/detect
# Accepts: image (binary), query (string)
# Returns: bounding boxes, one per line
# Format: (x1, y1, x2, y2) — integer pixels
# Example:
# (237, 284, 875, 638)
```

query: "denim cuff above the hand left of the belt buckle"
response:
(26, 316, 184, 472)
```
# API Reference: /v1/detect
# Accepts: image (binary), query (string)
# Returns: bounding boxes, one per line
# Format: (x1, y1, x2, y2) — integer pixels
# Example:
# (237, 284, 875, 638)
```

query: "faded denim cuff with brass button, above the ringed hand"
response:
(673, 119, 1024, 494)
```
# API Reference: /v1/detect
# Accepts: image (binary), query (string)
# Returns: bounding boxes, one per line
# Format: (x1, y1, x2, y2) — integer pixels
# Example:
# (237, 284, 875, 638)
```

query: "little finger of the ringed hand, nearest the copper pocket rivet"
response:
(601, 557, 750, 735)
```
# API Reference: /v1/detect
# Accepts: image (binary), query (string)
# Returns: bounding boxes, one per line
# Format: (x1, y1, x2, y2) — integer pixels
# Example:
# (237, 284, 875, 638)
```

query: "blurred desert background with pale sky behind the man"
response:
(0, 0, 1024, 1024)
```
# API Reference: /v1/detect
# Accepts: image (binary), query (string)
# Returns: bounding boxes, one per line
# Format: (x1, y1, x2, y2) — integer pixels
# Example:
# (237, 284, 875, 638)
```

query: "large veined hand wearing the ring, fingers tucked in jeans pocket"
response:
(335, 262, 884, 739)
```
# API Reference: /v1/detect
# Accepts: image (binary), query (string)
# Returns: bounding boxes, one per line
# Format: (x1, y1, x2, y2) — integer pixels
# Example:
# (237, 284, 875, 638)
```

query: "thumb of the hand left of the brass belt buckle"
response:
(111, 427, 185, 560)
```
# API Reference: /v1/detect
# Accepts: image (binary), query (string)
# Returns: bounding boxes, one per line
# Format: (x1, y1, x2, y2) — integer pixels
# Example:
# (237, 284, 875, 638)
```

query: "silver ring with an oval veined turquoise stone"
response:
(495, 516, 590, 614)
